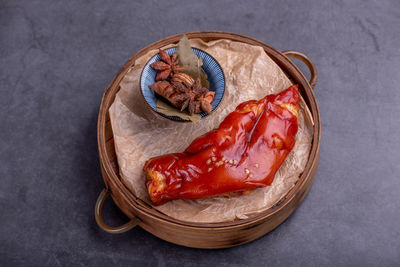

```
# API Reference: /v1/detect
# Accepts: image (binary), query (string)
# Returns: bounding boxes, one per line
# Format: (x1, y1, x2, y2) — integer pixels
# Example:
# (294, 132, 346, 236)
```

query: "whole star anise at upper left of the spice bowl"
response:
(150, 49, 184, 81)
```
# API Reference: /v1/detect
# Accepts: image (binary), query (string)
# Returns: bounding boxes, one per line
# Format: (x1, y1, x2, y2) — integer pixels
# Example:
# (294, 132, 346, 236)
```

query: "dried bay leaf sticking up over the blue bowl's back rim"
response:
(176, 35, 210, 89)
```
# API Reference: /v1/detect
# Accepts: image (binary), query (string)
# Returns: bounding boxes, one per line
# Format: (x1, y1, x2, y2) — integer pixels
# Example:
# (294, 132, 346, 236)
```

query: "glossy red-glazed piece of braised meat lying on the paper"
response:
(143, 85, 299, 205)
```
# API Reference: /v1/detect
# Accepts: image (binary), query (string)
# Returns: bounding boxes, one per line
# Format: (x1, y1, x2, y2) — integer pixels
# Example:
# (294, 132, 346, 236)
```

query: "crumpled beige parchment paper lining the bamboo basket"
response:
(109, 39, 313, 223)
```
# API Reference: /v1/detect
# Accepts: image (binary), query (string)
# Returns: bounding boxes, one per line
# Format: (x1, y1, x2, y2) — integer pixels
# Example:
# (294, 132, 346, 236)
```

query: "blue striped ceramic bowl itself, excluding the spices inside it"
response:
(140, 47, 225, 122)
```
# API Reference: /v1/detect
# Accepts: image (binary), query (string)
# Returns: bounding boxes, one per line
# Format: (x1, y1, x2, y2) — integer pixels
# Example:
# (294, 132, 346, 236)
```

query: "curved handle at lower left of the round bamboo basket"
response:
(94, 189, 139, 234)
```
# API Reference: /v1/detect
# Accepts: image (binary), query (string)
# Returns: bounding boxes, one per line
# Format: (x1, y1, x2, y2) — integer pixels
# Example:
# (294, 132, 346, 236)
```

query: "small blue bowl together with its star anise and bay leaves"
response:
(140, 37, 225, 122)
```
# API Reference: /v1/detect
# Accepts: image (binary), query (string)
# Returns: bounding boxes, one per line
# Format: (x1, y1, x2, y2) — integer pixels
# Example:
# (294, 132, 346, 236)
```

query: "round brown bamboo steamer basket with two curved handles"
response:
(95, 31, 321, 249)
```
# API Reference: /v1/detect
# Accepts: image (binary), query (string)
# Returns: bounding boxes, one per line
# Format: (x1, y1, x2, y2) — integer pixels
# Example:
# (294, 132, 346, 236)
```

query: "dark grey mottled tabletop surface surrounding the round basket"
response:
(0, 0, 400, 266)
